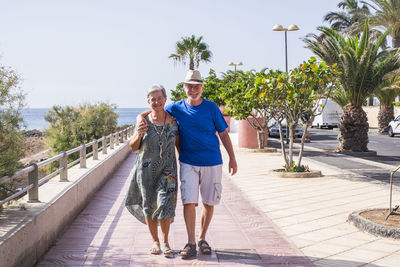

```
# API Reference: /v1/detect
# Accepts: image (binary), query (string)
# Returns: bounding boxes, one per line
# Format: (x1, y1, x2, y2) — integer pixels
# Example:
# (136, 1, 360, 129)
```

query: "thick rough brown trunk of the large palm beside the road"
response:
(338, 104, 369, 152)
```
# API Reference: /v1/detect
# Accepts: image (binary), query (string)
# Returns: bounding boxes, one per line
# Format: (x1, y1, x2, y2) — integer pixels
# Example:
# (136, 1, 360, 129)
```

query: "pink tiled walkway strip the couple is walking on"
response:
(37, 153, 313, 266)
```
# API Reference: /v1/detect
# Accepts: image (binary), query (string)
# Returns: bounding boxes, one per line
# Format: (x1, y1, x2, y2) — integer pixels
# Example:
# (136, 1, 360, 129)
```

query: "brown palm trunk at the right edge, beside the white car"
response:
(375, 74, 400, 133)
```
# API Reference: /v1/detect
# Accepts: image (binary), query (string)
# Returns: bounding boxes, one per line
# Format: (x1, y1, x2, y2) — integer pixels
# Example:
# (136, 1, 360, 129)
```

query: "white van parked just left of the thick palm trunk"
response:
(311, 98, 343, 129)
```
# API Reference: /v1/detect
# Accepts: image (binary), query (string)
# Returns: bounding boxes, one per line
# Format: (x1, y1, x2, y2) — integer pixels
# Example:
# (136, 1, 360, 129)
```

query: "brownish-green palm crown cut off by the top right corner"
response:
(363, 0, 400, 48)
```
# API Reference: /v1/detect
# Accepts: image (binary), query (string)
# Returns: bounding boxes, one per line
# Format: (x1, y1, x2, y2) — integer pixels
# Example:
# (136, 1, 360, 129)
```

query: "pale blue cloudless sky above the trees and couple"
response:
(0, 0, 339, 108)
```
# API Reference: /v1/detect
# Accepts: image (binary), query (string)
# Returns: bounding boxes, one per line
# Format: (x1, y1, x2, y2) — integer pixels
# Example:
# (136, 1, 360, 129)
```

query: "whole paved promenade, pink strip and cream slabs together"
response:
(38, 139, 400, 266)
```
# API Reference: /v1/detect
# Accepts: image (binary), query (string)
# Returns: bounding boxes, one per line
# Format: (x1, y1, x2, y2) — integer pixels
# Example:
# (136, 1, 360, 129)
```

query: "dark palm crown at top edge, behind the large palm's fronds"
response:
(324, 0, 370, 32)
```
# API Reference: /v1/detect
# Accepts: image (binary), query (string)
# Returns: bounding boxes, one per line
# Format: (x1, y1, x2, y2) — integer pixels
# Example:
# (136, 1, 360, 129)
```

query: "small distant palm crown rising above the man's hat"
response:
(169, 35, 212, 70)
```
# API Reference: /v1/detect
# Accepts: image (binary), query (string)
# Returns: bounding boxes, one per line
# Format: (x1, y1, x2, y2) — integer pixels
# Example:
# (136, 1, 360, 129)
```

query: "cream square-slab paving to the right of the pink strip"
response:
(225, 150, 400, 266)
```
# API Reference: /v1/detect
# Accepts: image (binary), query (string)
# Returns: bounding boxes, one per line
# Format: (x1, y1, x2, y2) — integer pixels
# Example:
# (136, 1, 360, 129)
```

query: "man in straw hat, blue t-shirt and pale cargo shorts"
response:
(141, 70, 237, 259)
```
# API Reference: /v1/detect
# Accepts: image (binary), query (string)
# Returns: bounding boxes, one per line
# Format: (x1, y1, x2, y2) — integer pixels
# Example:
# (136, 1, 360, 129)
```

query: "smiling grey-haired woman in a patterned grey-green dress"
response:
(125, 84, 179, 257)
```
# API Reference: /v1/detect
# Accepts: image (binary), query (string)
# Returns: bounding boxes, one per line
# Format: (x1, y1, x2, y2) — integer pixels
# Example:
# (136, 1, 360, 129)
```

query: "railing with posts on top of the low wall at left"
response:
(0, 125, 134, 206)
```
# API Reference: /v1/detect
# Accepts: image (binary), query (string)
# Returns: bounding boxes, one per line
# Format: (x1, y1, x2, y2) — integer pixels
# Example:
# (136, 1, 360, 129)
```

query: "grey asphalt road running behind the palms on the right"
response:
(268, 129, 400, 186)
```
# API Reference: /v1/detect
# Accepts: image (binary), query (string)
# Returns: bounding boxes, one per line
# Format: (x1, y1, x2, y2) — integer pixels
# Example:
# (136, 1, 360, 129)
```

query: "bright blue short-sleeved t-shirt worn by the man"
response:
(165, 99, 228, 166)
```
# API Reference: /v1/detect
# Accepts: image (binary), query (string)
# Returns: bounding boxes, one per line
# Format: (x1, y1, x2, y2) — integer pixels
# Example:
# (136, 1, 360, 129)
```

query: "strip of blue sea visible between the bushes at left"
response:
(22, 108, 149, 131)
